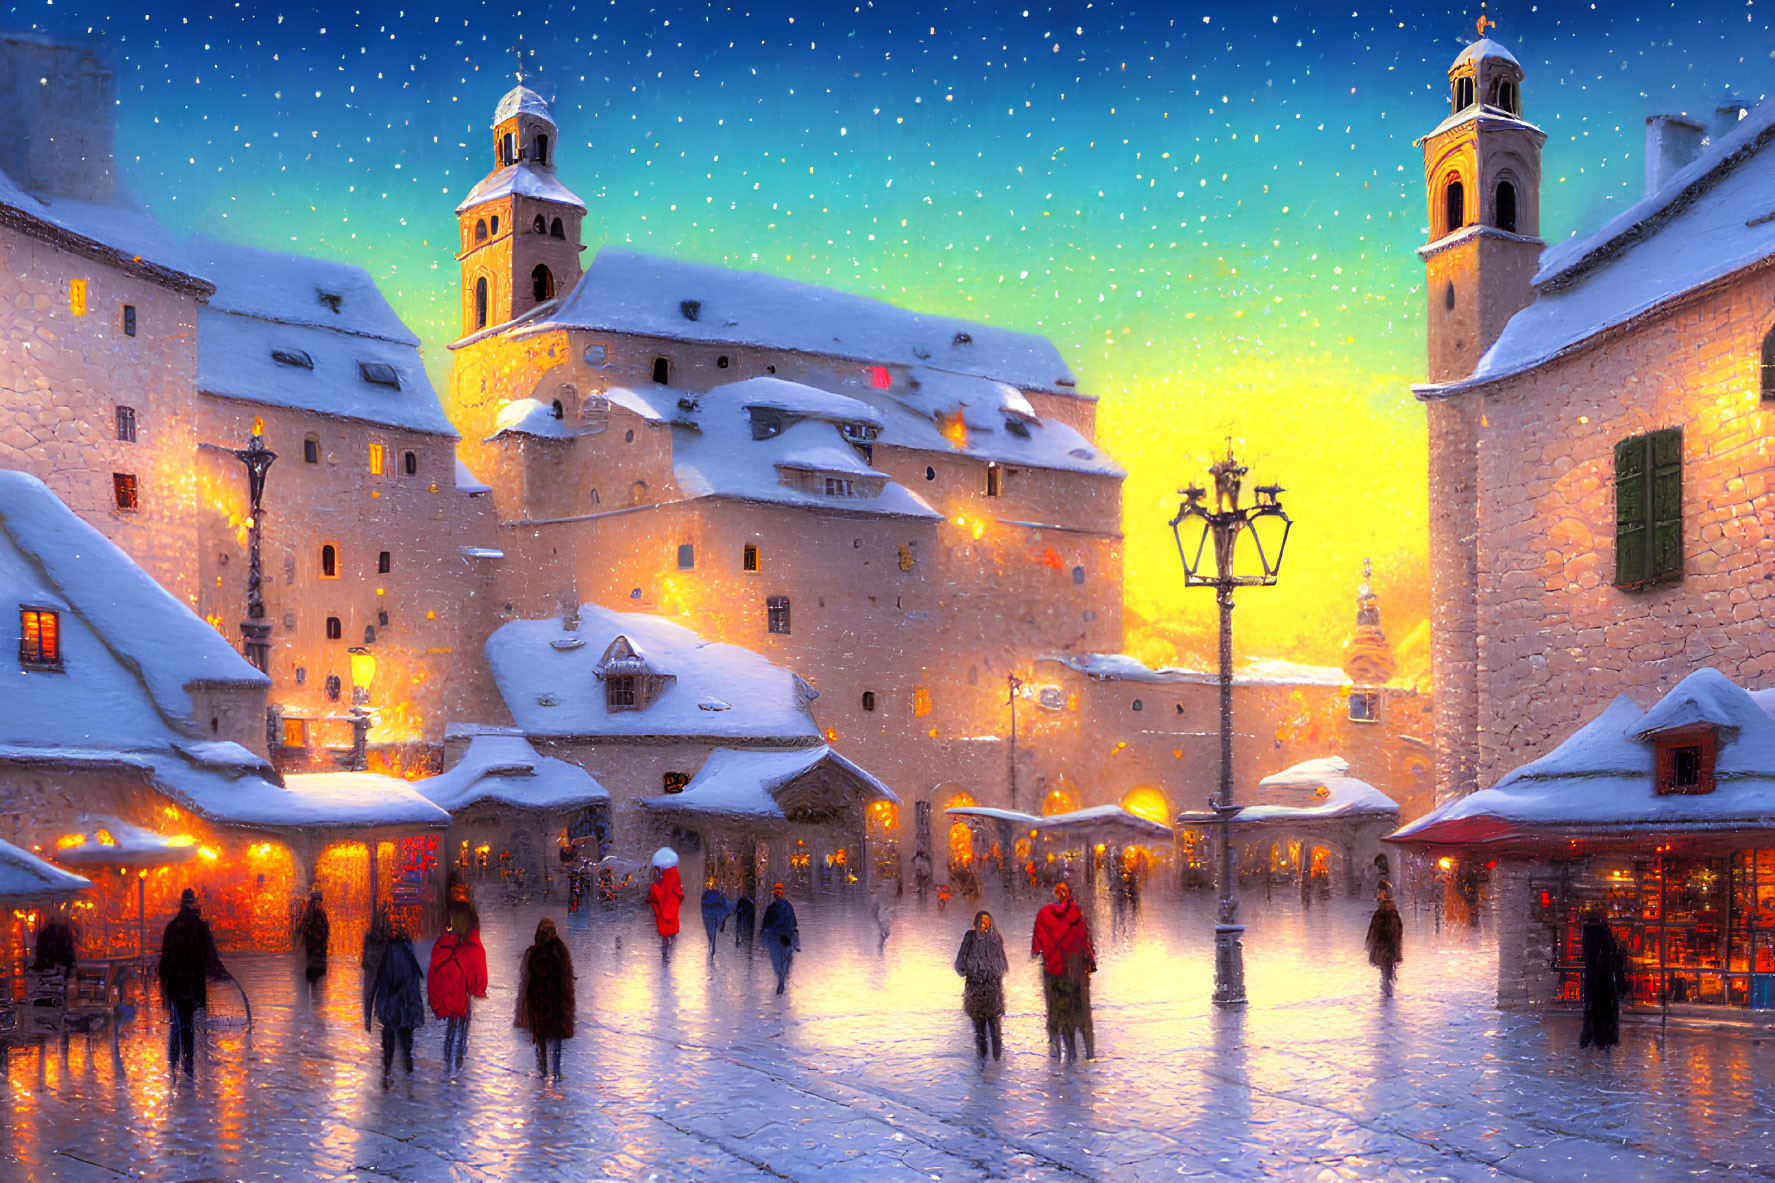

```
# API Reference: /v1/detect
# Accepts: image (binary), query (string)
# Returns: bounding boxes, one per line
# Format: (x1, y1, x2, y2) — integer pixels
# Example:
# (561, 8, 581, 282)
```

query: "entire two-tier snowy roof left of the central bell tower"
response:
(190, 240, 456, 437)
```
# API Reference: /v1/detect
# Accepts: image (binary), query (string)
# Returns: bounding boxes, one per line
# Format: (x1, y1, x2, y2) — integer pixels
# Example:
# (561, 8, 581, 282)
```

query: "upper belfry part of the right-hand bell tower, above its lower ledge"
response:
(1418, 16, 1546, 384)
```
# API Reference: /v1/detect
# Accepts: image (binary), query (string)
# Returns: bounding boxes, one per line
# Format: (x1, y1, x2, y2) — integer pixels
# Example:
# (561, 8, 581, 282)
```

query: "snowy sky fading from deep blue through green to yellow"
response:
(0, 0, 1775, 663)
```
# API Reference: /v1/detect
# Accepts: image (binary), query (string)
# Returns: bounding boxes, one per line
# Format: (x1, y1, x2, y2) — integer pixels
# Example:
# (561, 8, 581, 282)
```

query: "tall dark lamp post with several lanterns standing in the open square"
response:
(1172, 439, 1292, 1005)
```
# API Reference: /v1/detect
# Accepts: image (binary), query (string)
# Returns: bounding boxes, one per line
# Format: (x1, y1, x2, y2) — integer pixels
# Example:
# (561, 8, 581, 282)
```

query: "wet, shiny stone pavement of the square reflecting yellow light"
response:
(0, 884, 1775, 1181)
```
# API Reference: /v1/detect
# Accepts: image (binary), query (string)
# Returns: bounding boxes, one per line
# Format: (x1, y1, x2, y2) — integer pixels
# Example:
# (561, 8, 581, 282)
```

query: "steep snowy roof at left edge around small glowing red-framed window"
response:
(0, 469, 270, 731)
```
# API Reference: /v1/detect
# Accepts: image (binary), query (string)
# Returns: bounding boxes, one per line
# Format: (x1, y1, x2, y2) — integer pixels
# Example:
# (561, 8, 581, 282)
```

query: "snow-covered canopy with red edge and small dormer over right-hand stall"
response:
(1392, 670, 1775, 846)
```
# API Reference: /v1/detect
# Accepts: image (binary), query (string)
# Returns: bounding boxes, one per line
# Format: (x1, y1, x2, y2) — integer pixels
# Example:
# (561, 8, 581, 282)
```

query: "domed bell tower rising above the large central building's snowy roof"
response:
(456, 80, 586, 337)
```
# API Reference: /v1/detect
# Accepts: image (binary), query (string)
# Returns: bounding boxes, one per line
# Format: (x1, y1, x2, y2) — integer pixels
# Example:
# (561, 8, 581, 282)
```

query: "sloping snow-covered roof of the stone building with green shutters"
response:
(1431, 103, 1775, 389)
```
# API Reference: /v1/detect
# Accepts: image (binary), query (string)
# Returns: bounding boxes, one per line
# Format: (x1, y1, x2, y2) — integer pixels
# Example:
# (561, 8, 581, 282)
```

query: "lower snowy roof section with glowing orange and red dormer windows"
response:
(868, 366, 1125, 476)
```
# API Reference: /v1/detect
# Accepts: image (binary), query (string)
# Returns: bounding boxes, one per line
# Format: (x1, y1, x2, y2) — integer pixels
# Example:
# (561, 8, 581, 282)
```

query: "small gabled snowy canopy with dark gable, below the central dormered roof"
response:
(641, 744, 900, 821)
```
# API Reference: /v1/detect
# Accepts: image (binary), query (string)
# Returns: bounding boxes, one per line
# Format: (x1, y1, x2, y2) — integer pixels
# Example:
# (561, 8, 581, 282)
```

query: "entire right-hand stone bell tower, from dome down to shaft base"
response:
(1418, 18, 1546, 803)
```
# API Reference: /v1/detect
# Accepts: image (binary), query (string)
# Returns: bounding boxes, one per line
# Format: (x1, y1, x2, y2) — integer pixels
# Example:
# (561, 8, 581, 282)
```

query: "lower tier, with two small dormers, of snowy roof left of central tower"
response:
(197, 307, 456, 437)
